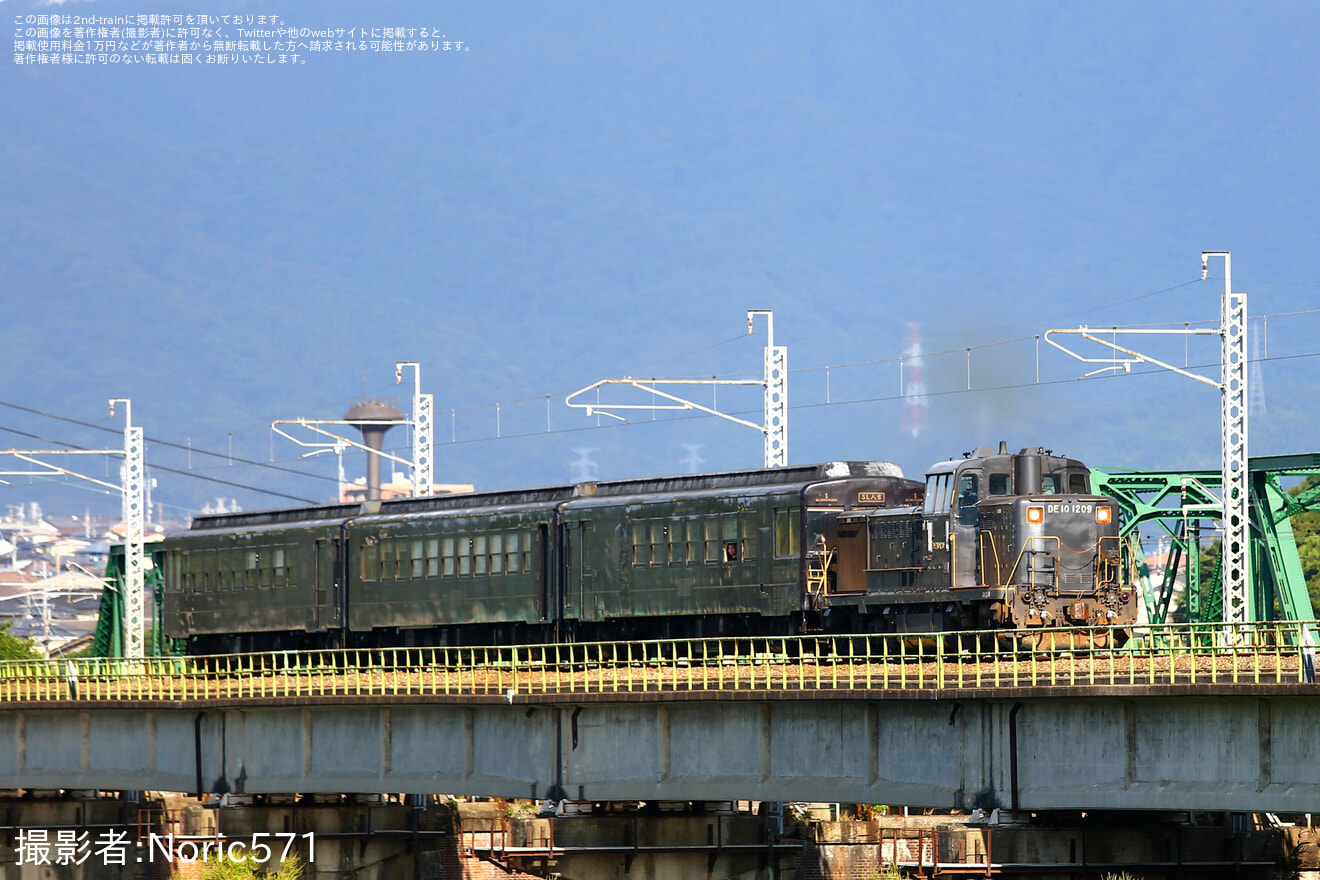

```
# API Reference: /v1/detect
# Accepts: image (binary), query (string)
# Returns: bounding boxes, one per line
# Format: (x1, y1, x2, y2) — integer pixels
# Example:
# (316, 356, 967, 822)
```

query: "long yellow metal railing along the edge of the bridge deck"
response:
(0, 621, 1320, 703)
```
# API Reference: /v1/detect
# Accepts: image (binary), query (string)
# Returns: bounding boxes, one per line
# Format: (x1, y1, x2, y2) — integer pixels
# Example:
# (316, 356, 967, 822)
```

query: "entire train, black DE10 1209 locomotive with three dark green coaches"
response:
(161, 443, 1137, 654)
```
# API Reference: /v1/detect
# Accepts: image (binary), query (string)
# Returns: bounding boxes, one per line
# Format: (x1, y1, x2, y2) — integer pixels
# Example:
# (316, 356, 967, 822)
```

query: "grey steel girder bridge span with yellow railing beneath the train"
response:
(0, 623, 1320, 811)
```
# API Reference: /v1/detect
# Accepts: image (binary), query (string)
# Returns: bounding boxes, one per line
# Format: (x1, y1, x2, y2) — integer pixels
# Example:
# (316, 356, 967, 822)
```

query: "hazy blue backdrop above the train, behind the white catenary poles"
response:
(0, 0, 1320, 509)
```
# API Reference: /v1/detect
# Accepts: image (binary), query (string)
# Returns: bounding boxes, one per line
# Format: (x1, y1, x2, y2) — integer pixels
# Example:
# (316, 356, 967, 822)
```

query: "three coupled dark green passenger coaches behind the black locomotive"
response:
(165, 462, 921, 653)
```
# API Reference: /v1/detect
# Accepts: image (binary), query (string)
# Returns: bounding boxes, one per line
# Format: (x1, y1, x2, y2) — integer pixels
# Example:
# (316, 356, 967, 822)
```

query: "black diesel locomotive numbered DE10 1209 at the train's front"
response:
(830, 443, 1135, 632)
